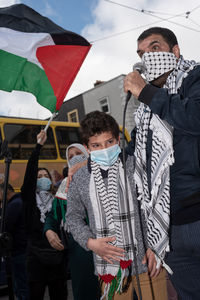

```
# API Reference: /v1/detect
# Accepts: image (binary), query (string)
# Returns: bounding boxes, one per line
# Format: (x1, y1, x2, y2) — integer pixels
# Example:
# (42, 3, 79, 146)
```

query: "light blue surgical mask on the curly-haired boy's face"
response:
(90, 144, 121, 166)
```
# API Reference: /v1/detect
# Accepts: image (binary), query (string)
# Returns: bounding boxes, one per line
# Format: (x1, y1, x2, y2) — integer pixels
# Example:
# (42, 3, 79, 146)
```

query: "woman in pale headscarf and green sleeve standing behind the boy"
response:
(44, 143, 100, 300)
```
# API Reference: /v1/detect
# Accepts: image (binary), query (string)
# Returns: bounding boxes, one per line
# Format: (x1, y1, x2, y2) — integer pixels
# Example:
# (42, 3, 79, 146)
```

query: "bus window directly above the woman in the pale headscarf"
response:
(55, 126, 81, 159)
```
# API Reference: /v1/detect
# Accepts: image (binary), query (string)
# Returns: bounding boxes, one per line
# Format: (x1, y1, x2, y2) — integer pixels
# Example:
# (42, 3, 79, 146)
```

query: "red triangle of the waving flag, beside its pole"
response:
(36, 45, 91, 110)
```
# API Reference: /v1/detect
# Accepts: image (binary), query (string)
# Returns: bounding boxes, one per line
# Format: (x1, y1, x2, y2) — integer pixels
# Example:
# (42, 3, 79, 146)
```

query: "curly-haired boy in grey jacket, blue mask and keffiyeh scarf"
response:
(66, 111, 167, 300)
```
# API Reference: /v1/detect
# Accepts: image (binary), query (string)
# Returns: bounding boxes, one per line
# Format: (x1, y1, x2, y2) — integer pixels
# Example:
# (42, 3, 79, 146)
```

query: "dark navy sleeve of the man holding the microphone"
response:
(138, 66, 200, 136)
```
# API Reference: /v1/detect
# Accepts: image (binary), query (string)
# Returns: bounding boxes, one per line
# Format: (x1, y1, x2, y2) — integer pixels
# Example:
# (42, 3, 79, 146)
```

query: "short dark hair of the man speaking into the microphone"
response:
(138, 27, 178, 49)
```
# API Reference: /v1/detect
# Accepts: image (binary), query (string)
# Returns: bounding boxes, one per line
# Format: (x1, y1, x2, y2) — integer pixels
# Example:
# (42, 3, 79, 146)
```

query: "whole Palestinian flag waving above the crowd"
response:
(0, 4, 91, 113)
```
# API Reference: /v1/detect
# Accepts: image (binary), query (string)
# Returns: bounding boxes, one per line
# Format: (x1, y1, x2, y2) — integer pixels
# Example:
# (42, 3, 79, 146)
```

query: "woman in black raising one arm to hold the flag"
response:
(21, 130, 67, 300)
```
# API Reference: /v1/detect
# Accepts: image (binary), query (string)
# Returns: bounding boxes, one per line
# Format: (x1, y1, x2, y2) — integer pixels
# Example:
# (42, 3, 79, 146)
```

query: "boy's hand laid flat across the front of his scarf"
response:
(87, 237, 125, 264)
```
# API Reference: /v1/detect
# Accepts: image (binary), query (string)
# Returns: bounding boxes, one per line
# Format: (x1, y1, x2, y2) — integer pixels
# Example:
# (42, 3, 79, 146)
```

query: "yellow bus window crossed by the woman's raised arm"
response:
(4, 123, 57, 160)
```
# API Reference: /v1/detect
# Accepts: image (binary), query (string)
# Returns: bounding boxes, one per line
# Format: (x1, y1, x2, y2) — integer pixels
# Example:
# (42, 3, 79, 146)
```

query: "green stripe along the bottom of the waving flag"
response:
(0, 50, 57, 112)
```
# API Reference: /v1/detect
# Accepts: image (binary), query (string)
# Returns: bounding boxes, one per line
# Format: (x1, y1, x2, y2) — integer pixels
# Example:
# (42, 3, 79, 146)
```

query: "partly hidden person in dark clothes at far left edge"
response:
(0, 183, 29, 300)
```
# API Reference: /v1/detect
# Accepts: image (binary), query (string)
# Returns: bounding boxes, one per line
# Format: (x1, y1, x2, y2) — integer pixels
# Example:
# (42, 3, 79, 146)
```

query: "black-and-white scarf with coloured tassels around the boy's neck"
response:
(90, 160, 137, 299)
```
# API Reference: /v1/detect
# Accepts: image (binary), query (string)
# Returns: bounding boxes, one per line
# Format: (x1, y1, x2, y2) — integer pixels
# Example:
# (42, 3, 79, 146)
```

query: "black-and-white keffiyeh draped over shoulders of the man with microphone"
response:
(134, 56, 197, 272)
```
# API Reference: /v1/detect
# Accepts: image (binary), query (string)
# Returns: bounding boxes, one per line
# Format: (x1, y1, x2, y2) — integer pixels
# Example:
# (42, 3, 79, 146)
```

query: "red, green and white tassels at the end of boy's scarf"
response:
(99, 260, 132, 300)
